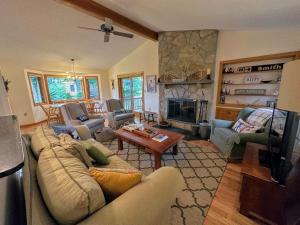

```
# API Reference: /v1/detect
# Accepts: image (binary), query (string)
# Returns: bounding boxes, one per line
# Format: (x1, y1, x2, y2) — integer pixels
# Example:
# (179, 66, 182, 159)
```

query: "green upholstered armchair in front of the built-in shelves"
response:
(210, 108, 270, 162)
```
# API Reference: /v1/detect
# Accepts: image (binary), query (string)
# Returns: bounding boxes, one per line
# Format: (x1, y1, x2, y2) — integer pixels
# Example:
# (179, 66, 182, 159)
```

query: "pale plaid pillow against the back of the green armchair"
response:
(246, 108, 273, 127)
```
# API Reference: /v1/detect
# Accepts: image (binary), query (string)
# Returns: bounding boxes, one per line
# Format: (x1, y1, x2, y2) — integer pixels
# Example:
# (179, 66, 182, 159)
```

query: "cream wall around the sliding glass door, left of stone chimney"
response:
(109, 41, 159, 112)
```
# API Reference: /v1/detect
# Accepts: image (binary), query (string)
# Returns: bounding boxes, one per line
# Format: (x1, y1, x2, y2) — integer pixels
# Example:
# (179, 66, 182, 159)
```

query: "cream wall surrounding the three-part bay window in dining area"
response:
(0, 59, 110, 125)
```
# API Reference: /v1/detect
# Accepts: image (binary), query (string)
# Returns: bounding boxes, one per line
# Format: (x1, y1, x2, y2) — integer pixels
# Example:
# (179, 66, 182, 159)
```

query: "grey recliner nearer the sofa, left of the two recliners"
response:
(61, 103, 105, 133)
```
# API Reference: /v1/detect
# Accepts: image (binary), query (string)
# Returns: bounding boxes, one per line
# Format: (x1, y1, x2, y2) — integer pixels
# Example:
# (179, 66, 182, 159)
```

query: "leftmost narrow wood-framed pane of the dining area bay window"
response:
(28, 73, 46, 105)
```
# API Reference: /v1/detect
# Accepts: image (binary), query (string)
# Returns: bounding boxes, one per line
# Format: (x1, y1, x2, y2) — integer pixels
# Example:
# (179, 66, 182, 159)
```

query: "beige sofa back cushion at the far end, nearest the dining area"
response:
(31, 126, 60, 159)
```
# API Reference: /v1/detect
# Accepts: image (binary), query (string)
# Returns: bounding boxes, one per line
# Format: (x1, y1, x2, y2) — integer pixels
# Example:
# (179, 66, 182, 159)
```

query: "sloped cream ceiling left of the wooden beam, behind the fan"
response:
(0, 0, 145, 70)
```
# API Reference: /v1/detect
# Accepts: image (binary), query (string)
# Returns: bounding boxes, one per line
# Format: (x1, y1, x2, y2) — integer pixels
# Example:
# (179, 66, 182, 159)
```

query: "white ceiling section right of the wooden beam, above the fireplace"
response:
(96, 0, 300, 31)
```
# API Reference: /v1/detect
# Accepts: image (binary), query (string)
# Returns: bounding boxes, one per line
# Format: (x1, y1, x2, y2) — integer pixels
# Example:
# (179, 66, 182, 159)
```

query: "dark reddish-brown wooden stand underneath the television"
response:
(240, 142, 285, 224)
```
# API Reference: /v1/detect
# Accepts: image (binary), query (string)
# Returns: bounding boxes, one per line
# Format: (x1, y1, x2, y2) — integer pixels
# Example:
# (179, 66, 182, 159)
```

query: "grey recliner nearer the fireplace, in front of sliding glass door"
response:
(106, 99, 134, 129)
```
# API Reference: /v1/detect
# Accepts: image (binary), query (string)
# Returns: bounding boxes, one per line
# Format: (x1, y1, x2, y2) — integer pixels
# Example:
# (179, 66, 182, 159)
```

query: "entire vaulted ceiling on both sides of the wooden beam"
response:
(0, 0, 300, 69)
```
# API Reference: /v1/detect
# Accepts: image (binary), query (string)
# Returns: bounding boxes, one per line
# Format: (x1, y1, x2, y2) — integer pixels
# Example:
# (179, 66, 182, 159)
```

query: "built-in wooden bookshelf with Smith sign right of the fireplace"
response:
(216, 51, 300, 120)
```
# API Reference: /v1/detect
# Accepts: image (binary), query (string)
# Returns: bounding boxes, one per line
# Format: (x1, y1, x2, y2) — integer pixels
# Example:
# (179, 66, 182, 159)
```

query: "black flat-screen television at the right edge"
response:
(268, 106, 300, 185)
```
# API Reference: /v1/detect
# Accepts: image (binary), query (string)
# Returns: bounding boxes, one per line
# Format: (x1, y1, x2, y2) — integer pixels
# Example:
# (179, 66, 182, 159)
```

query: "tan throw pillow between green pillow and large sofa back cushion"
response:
(59, 134, 92, 167)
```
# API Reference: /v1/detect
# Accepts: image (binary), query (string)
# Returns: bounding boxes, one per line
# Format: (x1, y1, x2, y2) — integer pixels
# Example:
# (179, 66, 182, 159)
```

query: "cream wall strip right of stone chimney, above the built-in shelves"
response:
(212, 29, 300, 117)
